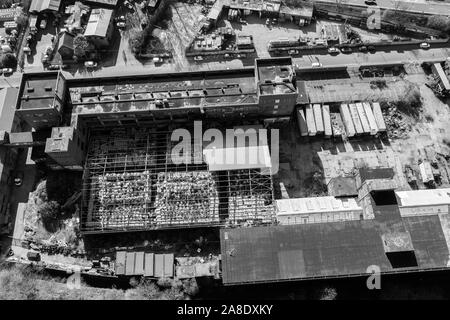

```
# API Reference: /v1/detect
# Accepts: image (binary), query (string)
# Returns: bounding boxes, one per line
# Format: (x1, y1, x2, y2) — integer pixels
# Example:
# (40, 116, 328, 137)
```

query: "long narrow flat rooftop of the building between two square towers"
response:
(69, 69, 257, 114)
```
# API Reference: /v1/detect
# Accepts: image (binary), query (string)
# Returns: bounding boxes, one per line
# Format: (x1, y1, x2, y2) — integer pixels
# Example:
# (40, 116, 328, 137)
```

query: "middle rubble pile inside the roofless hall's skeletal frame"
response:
(155, 171, 219, 225)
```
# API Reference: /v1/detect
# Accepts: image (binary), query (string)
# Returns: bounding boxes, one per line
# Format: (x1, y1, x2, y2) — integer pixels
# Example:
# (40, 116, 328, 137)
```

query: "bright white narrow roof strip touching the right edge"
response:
(395, 188, 450, 207)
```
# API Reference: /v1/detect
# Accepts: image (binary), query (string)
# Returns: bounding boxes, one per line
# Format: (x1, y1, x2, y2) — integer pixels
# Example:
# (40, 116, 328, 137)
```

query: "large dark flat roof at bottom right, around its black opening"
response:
(220, 216, 449, 285)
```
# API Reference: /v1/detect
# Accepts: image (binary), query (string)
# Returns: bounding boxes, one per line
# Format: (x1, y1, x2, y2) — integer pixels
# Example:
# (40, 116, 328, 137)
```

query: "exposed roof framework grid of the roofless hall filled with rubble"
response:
(81, 128, 275, 233)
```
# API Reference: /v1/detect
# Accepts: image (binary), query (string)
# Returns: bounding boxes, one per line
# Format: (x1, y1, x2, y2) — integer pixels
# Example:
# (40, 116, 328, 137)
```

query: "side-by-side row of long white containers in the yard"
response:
(297, 102, 386, 137)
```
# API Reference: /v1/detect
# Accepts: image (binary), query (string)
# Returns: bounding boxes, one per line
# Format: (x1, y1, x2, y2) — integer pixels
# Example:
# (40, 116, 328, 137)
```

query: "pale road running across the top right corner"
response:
(315, 0, 450, 15)
